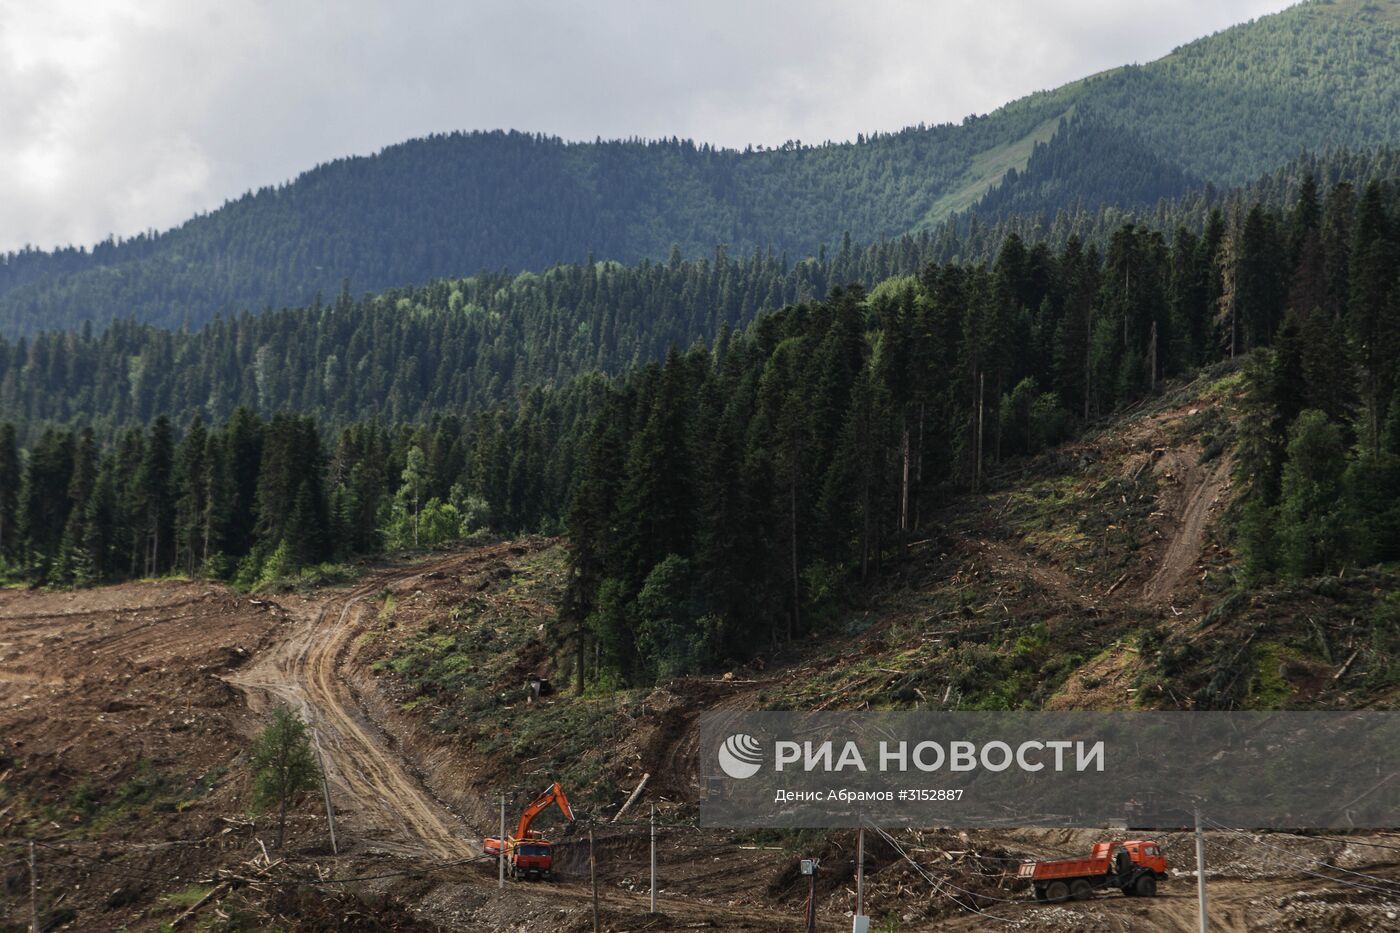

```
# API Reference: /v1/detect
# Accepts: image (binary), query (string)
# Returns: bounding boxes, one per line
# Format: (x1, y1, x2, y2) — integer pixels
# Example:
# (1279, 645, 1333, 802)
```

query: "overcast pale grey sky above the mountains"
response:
(0, 0, 1291, 249)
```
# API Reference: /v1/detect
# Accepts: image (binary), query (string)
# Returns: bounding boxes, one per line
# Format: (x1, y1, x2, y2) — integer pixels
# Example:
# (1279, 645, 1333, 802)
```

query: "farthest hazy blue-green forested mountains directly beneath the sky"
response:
(0, 0, 1400, 335)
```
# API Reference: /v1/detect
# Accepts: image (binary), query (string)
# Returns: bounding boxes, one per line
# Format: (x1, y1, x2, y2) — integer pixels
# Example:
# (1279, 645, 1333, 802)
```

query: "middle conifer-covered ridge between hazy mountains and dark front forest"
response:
(0, 145, 1400, 443)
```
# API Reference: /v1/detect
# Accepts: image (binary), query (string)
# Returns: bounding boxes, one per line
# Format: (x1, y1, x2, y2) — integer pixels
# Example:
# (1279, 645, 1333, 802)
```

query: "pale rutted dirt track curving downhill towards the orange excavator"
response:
(228, 556, 479, 860)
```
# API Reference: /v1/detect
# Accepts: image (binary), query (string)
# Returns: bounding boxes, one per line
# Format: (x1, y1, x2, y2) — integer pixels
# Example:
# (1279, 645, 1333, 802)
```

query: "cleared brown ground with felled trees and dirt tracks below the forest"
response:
(0, 367, 1400, 932)
